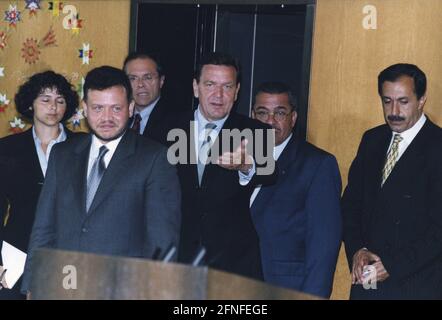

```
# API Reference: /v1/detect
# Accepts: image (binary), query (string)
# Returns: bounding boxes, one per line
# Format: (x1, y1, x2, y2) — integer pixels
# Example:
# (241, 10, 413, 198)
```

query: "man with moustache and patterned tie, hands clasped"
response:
(342, 64, 442, 299)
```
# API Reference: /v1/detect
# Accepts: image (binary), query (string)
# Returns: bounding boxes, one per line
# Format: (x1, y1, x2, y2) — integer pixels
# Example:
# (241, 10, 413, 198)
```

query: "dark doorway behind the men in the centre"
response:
(130, 1, 314, 138)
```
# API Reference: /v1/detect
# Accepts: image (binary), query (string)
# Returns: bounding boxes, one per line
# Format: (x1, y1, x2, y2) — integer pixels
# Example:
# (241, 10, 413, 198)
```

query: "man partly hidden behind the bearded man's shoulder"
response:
(123, 52, 171, 138)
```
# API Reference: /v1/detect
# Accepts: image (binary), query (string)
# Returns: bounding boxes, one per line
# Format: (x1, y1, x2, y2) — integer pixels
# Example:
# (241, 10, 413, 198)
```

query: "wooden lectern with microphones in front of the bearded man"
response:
(30, 249, 318, 300)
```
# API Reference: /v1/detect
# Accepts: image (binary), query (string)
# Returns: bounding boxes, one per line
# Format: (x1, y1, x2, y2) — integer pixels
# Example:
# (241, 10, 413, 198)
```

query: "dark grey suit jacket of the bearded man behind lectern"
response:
(22, 130, 180, 291)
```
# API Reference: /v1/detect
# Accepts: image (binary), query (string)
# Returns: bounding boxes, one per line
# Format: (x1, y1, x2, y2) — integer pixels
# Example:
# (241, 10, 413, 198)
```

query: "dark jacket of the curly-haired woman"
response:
(0, 128, 78, 299)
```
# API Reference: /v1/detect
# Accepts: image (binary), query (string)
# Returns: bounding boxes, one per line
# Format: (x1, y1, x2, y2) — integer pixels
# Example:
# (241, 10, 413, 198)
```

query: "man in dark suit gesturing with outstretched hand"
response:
(164, 53, 275, 279)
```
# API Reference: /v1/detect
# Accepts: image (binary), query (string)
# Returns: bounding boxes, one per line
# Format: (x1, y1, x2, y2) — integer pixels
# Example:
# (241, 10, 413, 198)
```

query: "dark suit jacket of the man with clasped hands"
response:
(342, 119, 442, 299)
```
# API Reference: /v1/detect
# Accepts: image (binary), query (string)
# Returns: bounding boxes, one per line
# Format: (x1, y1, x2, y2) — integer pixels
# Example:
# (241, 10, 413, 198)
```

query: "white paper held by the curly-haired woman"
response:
(2, 241, 26, 289)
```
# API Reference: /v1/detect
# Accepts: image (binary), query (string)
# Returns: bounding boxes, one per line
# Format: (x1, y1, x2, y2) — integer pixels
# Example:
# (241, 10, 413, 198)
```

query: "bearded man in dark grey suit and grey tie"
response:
(22, 66, 180, 291)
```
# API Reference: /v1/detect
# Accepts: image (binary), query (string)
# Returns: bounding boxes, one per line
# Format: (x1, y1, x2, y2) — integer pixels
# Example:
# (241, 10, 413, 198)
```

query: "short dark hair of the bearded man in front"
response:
(83, 66, 132, 102)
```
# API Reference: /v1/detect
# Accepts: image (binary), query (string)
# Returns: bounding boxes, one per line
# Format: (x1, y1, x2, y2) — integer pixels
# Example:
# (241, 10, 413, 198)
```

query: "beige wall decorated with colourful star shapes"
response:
(0, 0, 130, 137)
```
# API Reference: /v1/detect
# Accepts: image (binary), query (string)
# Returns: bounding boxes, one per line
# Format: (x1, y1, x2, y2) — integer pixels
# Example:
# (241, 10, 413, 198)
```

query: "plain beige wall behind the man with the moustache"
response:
(307, 0, 442, 299)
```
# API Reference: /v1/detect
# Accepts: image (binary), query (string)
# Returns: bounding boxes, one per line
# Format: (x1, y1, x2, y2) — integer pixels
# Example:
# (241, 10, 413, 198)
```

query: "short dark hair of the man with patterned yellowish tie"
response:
(378, 63, 427, 100)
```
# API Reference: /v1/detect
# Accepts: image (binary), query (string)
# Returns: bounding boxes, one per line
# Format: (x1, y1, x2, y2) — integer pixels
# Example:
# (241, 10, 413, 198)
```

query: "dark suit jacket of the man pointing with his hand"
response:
(161, 111, 276, 279)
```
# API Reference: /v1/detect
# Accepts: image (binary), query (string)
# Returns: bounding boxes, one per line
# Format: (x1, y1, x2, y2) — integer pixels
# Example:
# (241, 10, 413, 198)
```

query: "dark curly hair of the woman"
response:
(14, 70, 78, 122)
